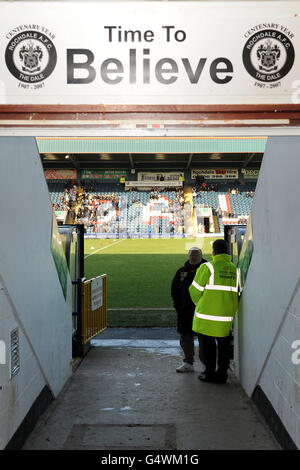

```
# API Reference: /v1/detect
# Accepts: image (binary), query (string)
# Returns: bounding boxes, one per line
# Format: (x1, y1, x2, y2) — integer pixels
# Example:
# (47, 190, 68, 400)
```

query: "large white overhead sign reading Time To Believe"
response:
(0, 1, 300, 105)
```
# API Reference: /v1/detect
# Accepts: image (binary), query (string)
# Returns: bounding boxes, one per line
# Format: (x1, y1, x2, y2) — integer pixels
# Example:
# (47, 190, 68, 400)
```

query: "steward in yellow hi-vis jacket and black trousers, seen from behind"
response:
(189, 240, 238, 383)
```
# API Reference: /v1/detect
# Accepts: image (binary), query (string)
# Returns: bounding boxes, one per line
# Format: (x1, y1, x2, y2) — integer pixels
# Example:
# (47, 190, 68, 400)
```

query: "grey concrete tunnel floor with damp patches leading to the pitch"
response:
(23, 328, 280, 451)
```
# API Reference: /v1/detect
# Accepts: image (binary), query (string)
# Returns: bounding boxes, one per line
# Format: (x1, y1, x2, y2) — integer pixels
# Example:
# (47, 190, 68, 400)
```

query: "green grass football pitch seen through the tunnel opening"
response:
(84, 237, 215, 327)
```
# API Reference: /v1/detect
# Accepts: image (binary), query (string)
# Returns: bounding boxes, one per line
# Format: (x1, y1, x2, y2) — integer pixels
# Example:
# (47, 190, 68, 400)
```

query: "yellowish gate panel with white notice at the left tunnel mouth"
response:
(81, 274, 107, 344)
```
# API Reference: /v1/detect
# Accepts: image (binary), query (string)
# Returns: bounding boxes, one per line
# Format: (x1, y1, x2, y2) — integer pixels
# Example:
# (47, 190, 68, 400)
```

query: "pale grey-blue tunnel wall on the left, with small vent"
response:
(0, 137, 72, 449)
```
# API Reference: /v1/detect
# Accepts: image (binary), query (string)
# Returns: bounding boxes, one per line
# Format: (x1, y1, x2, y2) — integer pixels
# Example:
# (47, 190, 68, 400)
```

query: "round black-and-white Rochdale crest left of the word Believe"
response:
(5, 30, 57, 83)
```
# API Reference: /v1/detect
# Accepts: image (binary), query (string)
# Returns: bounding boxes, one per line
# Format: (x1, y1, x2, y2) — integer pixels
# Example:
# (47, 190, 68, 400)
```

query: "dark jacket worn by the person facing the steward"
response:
(171, 258, 206, 335)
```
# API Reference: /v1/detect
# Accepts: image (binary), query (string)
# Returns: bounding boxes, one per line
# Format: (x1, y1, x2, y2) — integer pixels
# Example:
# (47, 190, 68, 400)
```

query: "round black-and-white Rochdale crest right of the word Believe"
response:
(243, 29, 295, 82)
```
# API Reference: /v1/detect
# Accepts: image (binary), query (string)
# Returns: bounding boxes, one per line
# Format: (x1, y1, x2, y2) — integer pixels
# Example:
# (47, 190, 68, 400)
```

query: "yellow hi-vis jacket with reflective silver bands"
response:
(189, 253, 238, 336)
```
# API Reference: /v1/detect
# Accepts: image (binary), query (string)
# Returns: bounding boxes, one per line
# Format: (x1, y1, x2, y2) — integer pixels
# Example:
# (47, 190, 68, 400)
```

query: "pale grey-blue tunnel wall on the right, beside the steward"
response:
(236, 137, 300, 448)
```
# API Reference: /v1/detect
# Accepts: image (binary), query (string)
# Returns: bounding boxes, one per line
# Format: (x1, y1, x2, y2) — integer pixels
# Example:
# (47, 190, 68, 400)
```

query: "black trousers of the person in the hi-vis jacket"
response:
(199, 334, 231, 374)
